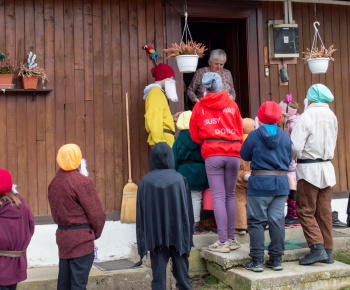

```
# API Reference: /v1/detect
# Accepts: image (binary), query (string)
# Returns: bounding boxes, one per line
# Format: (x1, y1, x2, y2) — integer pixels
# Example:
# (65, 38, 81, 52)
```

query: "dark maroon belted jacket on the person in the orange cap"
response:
(48, 169, 106, 259)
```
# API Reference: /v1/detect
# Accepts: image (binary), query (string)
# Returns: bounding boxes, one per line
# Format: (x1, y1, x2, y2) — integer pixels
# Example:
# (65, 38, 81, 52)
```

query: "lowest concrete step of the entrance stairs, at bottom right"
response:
(208, 261, 350, 290)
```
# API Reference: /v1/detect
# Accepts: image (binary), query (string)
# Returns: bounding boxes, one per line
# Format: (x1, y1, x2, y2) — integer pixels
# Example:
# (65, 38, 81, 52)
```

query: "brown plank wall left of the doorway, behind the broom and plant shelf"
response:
(0, 0, 165, 216)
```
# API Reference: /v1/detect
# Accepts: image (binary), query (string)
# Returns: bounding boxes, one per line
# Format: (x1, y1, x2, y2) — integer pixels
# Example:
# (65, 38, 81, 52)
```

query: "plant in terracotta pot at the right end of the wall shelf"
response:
(18, 52, 48, 89)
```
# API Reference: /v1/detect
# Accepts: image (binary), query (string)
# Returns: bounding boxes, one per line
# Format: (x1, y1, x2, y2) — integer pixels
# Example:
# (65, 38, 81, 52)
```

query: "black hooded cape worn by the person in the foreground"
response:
(136, 142, 194, 259)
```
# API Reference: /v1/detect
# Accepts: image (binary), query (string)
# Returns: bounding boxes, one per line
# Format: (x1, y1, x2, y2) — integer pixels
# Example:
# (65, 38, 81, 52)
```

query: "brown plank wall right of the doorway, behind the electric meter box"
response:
(263, 2, 350, 191)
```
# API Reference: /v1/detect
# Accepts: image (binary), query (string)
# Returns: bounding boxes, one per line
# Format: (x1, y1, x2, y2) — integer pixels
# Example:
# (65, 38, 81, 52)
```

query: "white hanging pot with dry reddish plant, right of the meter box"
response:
(303, 44, 336, 74)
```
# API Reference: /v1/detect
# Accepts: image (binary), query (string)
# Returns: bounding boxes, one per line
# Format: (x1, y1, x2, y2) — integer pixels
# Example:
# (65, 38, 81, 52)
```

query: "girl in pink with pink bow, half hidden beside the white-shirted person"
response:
(279, 101, 300, 227)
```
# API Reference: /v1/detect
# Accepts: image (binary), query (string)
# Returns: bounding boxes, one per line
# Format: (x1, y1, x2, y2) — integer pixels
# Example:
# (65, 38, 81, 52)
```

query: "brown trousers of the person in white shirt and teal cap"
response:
(296, 179, 333, 249)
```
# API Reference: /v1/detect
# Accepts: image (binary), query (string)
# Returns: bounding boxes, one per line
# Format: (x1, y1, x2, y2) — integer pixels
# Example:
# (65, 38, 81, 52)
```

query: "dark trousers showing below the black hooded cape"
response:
(151, 246, 191, 290)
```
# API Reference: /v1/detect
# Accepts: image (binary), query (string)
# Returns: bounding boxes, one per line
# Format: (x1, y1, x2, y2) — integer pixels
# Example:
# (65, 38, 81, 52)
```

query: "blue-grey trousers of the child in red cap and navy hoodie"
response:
(247, 195, 287, 257)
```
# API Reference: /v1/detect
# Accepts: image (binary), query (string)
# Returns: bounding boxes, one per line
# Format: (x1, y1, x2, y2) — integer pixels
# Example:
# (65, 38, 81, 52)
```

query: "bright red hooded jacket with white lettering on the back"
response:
(190, 91, 243, 159)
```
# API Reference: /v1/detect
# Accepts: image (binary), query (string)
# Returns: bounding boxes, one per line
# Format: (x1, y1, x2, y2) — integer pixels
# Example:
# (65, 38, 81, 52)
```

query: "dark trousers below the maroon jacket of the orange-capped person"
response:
(57, 252, 94, 290)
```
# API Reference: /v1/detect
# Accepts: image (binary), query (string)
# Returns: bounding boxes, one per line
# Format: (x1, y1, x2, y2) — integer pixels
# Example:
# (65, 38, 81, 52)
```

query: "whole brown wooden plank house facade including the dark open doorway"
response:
(0, 0, 350, 219)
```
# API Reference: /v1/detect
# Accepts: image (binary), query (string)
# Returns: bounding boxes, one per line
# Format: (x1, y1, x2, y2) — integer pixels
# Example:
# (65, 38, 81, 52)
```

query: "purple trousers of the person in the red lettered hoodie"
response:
(205, 156, 240, 243)
